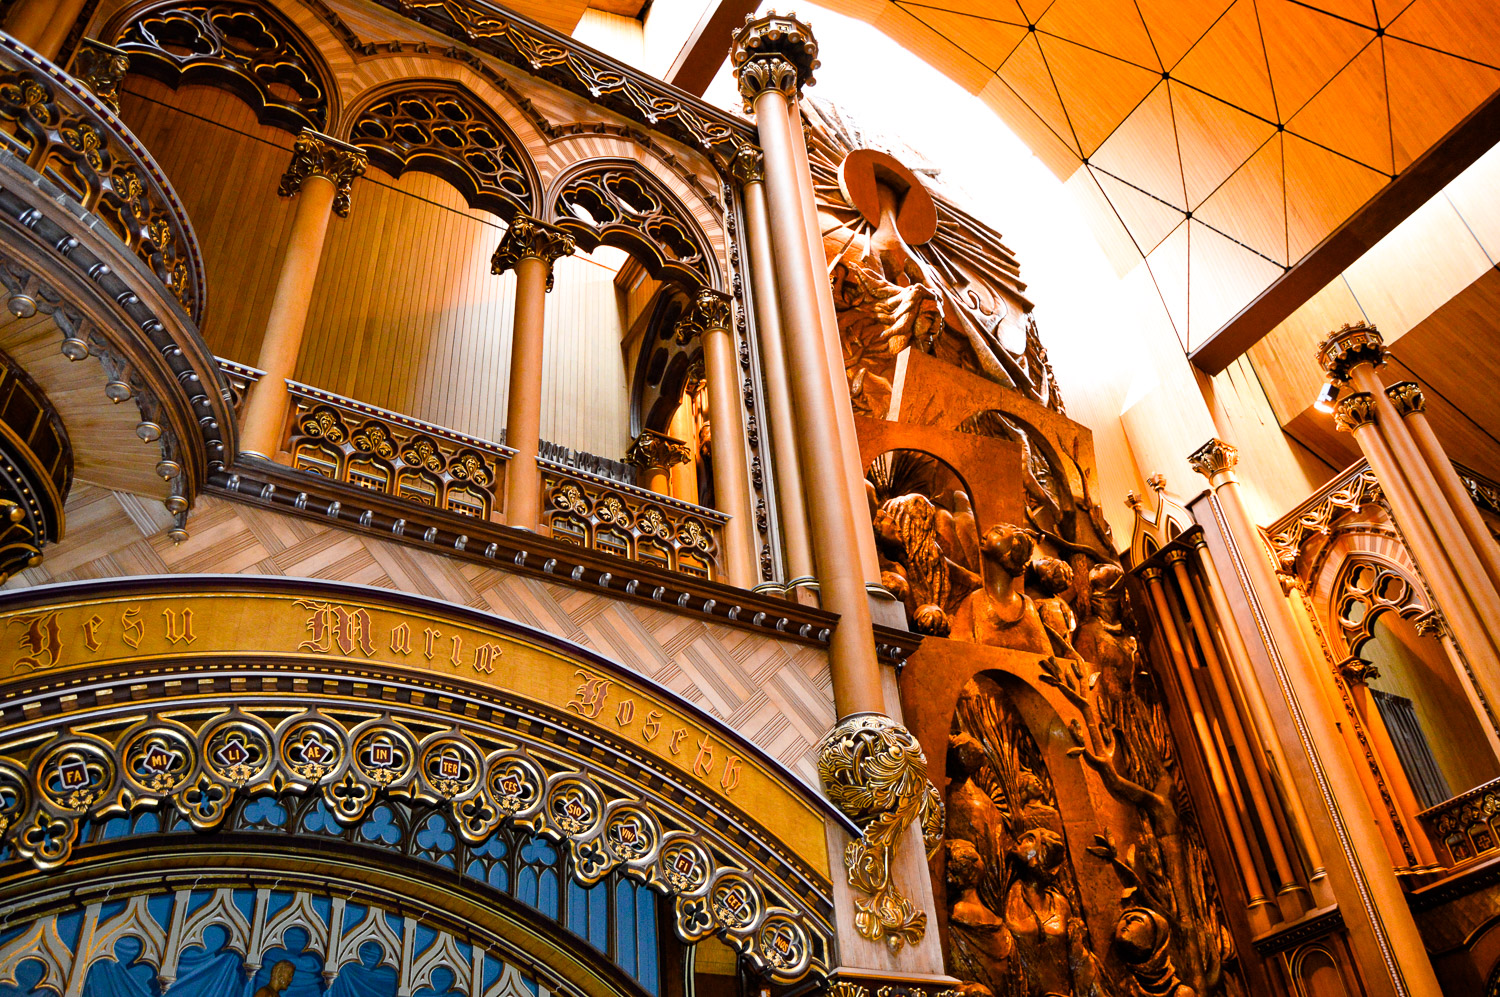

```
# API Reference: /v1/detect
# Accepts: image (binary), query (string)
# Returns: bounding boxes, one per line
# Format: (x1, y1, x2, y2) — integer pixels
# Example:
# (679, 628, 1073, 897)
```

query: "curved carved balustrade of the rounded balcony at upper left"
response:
(0, 36, 204, 321)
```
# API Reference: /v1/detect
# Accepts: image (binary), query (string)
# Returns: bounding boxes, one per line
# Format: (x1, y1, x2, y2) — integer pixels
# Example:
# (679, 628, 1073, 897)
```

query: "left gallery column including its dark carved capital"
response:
(240, 129, 369, 460)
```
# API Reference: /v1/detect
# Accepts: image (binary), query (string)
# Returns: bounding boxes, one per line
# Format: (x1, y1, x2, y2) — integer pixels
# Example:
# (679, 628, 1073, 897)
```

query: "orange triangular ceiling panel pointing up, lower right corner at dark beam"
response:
(1287, 39, 1395, 175)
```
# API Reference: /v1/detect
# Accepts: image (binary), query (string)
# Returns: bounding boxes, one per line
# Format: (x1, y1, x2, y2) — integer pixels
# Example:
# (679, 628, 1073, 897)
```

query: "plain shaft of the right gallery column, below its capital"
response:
(702, 319, 759, 589)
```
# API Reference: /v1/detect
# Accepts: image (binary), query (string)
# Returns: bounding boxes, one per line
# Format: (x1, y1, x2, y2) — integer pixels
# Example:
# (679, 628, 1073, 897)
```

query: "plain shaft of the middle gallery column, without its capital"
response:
(506, 256, 552, 531)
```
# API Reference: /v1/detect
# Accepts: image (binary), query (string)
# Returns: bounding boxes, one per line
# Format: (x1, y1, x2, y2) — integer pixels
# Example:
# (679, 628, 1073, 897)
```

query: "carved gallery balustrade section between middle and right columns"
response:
(539, 460, 729, 580)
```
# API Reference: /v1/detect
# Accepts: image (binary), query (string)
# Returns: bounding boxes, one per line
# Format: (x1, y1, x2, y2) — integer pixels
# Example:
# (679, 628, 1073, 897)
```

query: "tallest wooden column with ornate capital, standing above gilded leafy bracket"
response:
(734, 19, 885, 718)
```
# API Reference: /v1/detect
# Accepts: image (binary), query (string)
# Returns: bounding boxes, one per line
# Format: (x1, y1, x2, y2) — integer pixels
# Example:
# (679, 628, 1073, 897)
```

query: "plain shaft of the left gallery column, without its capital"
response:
(240, 175, 336, 460)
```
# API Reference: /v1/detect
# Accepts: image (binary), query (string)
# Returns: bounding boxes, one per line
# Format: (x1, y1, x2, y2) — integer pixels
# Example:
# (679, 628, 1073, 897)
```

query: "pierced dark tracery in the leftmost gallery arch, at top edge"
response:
(114, 3, 335, 132)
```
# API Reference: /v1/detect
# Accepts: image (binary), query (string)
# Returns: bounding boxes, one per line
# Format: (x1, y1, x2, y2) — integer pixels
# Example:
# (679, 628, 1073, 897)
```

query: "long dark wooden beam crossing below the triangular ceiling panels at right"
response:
(1188, 83, 1500, 375)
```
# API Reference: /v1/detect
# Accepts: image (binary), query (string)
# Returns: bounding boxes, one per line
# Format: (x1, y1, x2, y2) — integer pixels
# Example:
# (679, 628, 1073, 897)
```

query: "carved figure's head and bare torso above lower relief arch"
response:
(953, 523, 1052, 654)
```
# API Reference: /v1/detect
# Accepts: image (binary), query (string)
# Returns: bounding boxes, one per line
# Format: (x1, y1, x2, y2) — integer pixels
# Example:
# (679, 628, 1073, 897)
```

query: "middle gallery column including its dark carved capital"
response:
(489, 214, 575, 532)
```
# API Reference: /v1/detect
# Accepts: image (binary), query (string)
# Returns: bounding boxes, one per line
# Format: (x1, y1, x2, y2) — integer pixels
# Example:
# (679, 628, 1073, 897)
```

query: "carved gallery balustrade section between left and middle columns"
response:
(283, 380, 515, 520)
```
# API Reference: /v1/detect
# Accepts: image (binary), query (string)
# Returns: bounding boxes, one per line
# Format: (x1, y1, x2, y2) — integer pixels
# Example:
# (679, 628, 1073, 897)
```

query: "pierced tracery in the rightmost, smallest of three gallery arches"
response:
(549, 159, 720, 288)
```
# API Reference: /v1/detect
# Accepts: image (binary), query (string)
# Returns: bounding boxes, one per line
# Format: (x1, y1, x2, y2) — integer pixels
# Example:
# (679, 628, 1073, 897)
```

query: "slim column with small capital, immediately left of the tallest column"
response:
(729, 147, 816, 589)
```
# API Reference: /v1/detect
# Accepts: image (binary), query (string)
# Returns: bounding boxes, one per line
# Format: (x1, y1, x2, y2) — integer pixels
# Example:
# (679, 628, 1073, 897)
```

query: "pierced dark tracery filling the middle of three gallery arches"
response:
(350, 81, 539, 219)
